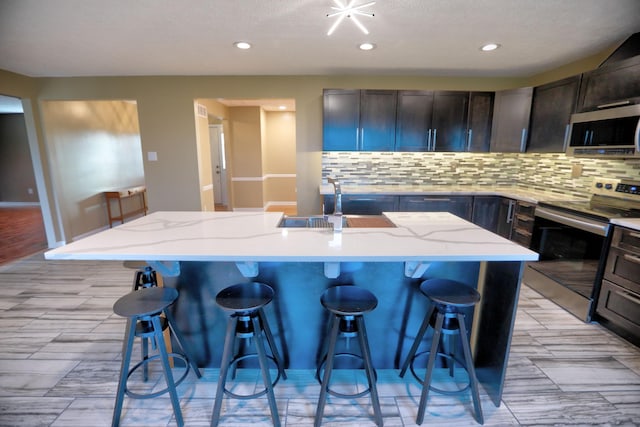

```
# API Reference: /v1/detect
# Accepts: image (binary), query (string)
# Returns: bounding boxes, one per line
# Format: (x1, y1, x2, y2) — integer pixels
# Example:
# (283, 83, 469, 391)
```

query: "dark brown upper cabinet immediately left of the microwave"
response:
(527, 76, 580, 153)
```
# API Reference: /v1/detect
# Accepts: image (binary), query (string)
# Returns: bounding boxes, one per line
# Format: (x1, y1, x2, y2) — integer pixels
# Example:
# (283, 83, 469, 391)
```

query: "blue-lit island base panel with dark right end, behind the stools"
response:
(164, 262, 522, 406)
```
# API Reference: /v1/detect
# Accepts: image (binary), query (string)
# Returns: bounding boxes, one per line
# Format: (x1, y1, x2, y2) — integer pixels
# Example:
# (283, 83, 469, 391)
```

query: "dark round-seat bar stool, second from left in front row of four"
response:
(211, 282, 287, 427)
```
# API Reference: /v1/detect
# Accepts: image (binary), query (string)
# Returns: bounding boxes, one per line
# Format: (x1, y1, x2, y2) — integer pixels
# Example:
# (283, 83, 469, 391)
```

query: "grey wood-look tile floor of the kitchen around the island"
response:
(0, 255, 640, 427)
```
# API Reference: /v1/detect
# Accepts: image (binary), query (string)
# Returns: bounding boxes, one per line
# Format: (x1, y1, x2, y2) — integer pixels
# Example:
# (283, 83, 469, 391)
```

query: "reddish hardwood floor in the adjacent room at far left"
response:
(0, 206, 47, 265)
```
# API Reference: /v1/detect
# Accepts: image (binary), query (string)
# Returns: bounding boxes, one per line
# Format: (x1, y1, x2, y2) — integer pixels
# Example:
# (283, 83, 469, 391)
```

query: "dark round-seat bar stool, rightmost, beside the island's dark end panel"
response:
(400, 279, 484, 424)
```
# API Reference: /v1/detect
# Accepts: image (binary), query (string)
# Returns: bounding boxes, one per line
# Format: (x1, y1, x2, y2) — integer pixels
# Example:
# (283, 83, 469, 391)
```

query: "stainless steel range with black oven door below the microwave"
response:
(523, 179, 640, 321)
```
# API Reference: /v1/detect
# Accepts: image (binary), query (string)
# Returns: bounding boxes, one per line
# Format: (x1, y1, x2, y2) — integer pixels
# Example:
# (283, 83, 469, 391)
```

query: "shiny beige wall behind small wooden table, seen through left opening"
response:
(42, 101, 145, 241)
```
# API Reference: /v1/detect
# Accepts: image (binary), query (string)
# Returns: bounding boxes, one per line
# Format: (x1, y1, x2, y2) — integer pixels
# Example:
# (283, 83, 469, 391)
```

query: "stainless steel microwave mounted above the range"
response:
(567, 105, 640, 158)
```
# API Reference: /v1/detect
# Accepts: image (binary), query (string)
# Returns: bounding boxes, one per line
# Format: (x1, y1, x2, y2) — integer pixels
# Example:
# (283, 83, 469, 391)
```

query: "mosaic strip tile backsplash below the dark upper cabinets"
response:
(322, 151, 640, 197)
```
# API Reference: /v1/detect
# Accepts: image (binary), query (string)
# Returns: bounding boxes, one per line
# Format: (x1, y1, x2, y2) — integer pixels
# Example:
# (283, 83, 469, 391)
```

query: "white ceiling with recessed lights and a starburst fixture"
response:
(0, 0, 640, 77)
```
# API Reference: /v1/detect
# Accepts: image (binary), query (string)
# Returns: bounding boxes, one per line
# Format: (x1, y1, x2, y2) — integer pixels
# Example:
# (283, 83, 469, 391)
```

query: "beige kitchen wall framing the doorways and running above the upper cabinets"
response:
(0, 48, 613, 245)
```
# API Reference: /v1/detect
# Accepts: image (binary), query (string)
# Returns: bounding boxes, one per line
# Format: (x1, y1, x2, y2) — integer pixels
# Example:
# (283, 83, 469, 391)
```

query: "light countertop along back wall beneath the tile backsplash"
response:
(319, 184, 586, 203)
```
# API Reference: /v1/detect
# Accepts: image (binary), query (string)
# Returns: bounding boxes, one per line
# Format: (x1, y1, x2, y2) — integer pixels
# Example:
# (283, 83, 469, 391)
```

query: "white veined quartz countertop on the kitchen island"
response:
(45, 212, 538, 262)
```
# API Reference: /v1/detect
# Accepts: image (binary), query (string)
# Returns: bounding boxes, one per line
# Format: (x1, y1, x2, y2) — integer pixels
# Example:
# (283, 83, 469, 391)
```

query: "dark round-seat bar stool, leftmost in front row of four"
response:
(111, 287, 202, 426)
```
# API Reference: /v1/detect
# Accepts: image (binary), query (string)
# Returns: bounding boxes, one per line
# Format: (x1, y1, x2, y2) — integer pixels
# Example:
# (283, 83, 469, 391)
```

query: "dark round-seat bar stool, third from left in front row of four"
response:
(315, 285, 383, 427)
